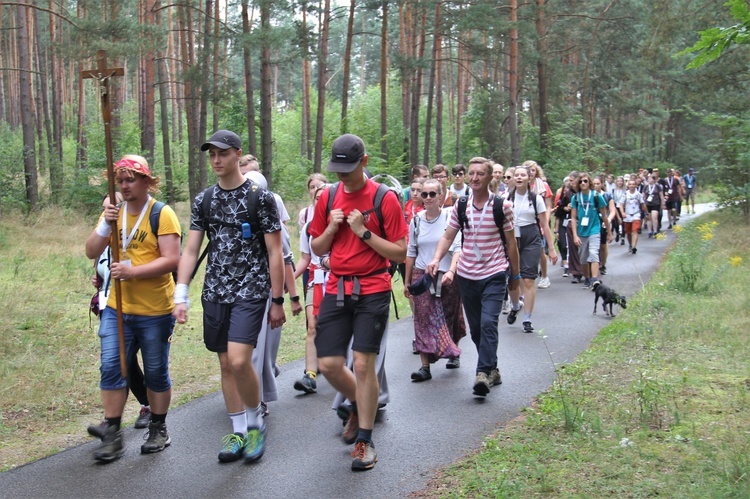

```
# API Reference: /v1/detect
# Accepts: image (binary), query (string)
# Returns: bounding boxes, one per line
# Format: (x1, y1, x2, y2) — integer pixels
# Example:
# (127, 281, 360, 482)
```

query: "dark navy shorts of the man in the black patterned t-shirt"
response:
(201, 298, 268, 353)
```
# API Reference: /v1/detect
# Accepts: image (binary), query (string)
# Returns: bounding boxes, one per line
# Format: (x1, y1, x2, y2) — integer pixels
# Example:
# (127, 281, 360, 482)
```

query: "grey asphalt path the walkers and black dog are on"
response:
(0, 206, 708, 498)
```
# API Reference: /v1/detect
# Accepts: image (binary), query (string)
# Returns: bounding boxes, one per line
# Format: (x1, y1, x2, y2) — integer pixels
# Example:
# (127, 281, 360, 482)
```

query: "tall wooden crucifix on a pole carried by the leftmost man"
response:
(81, 50, 128, 379)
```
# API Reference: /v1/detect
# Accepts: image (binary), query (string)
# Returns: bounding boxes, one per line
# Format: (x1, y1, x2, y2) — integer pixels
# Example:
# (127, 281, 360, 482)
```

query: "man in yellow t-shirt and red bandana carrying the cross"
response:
(86, 155, 180, 462)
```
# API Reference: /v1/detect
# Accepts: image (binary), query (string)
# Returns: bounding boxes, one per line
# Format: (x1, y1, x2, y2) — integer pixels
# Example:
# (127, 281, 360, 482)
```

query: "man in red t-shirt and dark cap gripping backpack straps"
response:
(309, 134, 408, 470)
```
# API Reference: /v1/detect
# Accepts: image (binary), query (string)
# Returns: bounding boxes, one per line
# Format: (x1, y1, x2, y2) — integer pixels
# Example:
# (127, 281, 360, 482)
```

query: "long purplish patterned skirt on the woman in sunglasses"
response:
(412, 269, 466, 362)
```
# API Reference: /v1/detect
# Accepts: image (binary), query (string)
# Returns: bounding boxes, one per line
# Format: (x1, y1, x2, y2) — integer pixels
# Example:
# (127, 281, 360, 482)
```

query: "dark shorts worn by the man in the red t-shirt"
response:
(315, 291, 391, 357)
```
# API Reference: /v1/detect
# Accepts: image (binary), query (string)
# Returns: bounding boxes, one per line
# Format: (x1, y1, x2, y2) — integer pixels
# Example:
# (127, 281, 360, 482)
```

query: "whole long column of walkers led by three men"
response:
(86, 130, 697, 471)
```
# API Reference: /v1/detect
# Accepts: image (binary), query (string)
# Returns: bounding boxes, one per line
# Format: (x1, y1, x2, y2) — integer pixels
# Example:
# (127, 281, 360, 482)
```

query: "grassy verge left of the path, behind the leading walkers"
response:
(0, 203, 409, 470)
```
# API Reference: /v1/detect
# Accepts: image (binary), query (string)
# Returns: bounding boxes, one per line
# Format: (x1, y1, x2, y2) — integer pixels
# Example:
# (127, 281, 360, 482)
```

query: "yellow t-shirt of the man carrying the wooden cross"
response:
(102, 199, 181, 316)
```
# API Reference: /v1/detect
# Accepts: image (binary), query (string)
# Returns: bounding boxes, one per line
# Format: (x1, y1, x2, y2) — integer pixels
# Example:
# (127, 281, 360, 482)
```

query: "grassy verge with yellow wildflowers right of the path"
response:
(425, 209, 750, 497)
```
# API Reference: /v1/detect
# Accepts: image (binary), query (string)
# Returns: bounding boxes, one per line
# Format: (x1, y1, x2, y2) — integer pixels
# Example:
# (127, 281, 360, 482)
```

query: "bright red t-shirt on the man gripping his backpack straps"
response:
(309, 180, 409, 295)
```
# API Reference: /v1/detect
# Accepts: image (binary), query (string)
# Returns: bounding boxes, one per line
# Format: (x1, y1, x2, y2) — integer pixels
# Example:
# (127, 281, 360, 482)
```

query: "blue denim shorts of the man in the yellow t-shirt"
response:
(99, 307, 174, 393)
